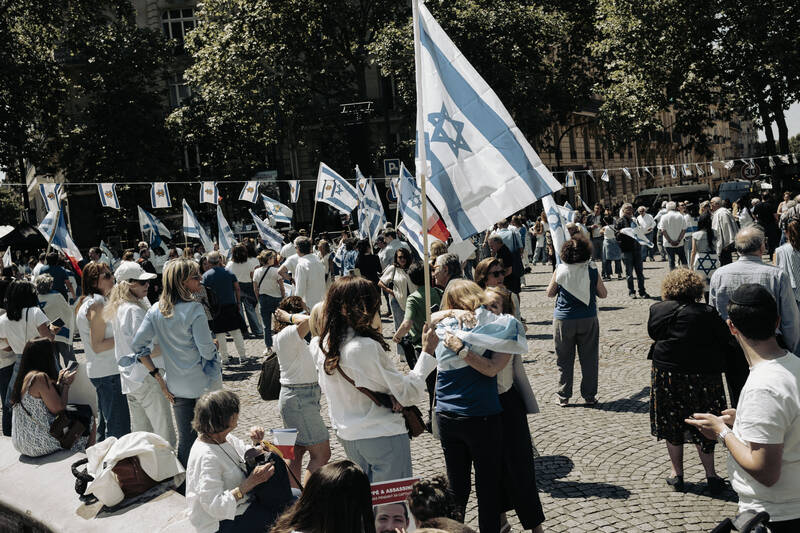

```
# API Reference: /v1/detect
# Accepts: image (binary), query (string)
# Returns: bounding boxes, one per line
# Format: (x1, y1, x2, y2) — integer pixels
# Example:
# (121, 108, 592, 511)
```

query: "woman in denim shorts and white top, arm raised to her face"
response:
(273, 296, 331, 479)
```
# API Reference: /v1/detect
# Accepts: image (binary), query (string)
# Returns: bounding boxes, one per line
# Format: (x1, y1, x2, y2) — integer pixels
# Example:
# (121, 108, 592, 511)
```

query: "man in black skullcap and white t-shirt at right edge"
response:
(686, 283, 800, 533)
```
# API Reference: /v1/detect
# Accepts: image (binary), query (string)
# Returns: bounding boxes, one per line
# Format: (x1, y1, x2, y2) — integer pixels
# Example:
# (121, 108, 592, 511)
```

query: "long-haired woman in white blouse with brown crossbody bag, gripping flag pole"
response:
(312, 276, 439, 483)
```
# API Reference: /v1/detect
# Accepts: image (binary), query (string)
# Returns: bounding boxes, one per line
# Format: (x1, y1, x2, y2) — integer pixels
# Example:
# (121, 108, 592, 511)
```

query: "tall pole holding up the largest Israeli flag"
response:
(412, 0, 431, 323)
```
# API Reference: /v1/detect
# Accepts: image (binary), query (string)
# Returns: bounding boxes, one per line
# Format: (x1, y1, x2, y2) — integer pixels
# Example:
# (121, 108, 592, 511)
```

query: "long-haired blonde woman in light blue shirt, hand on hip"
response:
(131, 259, 222, 466)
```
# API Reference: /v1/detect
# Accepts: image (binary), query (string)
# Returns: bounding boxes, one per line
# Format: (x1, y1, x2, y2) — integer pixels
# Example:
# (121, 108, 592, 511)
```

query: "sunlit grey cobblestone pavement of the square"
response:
(79, 262, 736, 532)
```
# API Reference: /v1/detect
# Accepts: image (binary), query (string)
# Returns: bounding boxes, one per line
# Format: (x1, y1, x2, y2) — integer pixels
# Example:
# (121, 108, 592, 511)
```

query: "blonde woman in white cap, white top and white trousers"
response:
(103, 263, 177, 447)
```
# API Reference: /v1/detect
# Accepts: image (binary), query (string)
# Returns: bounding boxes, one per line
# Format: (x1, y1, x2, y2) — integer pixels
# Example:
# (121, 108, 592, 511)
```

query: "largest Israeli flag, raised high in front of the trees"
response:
(414, 0, 561, 240)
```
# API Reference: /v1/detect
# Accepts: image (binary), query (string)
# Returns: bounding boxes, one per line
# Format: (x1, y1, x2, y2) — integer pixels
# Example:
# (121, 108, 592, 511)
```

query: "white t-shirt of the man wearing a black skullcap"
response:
(728, 352, 800, 522)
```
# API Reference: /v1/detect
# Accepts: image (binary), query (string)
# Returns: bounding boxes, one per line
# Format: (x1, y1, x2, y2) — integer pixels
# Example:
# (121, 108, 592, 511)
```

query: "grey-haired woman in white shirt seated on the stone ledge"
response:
(186, 390, 283, 533)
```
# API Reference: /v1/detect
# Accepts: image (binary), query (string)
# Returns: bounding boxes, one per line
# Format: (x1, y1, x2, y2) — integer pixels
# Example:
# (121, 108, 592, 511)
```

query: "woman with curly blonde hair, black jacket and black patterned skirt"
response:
(647, 269, 735, 494)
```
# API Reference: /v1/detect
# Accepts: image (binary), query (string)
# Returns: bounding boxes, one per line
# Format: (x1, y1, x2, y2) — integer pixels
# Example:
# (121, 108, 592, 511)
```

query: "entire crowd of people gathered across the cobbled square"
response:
(0, 188, 800, 533)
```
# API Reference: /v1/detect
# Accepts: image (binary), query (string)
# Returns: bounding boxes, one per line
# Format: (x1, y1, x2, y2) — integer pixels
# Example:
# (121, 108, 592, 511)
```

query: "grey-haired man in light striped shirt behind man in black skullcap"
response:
(709, 225, 800, 353)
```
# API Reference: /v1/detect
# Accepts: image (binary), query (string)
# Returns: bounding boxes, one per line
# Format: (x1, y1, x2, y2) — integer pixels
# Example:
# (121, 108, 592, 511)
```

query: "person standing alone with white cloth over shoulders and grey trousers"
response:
(547, 235, 608, 407)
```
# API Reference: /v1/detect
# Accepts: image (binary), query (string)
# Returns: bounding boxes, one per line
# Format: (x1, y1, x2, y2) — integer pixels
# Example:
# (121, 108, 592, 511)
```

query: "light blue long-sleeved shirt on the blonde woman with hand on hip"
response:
(131, 302, 222, 398)
